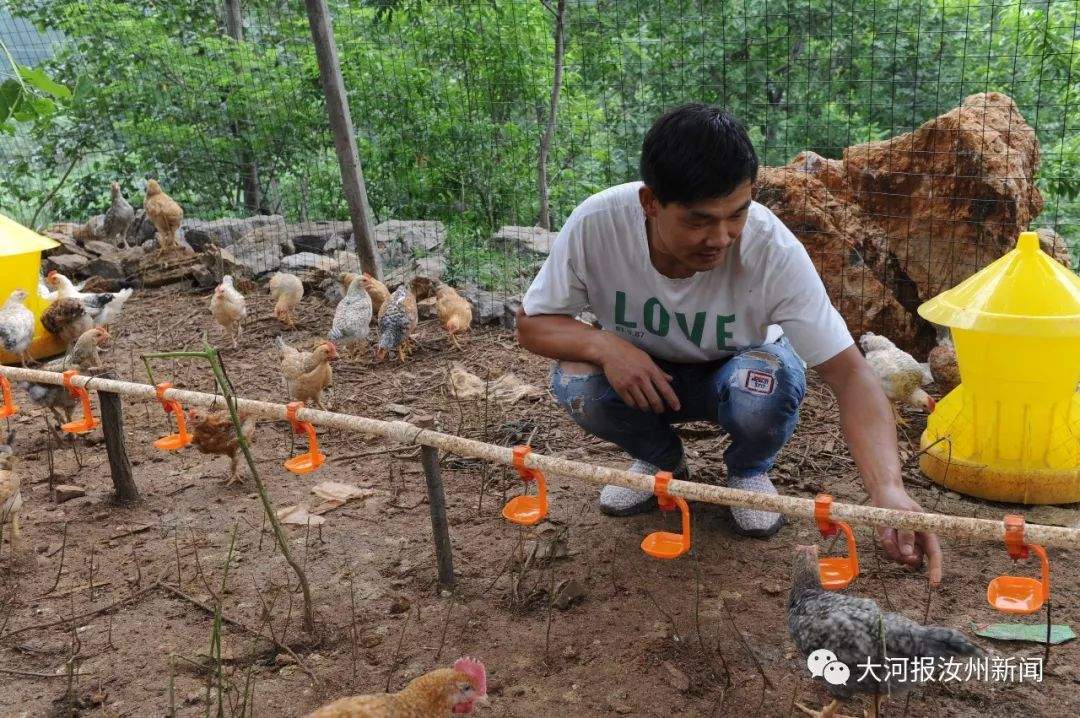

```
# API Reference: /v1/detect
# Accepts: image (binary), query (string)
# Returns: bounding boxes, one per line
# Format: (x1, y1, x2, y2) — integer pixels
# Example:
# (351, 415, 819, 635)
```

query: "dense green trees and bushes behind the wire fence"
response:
(0, 0, 1080, 268)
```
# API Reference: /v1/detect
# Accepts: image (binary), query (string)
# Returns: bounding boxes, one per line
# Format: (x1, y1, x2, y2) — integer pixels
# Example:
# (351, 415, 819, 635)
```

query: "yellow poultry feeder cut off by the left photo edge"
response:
(0, 210, 64, 364)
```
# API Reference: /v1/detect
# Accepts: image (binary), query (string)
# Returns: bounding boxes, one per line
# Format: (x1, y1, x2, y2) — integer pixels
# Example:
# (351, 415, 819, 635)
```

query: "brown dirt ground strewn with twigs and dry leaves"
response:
(0, 282, 1080, 716)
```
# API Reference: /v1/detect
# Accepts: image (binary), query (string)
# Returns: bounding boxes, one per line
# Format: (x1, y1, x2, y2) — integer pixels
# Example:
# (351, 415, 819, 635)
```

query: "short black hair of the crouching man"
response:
(642, 103, 757, 204)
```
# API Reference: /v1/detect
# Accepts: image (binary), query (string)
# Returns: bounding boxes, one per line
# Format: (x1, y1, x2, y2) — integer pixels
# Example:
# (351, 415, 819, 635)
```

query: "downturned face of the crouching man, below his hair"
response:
(639, 180, 751, 273)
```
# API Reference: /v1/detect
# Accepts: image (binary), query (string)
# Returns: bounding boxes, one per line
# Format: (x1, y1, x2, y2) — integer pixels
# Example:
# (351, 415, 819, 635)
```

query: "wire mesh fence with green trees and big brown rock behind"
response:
(0, 0, 1080, 346)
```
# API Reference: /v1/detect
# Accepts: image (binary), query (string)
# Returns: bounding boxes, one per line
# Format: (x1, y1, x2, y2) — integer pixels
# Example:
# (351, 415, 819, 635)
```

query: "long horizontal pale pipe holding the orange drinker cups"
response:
(0, 366, 1080, 547)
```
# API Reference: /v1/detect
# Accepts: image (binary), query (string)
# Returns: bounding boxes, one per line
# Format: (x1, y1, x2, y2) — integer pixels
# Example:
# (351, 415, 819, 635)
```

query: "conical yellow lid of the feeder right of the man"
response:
(919, 232, 1080, 338)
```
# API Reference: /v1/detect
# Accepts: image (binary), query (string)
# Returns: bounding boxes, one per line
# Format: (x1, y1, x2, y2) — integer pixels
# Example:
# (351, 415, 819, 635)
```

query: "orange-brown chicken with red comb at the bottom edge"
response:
(307, 659, 487, 718)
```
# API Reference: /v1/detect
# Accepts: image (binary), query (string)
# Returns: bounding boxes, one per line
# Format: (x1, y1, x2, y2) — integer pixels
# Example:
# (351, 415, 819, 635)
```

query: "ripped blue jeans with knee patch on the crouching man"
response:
(551, 339, 806, 476)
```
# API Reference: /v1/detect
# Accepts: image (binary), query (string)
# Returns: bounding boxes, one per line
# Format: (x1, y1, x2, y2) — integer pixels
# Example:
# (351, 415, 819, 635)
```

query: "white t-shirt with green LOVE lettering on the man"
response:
(522, 182, 854, 366)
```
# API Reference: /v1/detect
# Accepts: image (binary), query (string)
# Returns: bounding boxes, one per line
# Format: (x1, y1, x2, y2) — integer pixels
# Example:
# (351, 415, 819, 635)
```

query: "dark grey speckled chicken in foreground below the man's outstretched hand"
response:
(787, 546, 984, 718)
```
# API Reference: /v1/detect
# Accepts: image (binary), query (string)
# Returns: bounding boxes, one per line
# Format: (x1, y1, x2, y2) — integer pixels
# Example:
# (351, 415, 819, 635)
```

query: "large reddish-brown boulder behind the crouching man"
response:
(756, 93, 1042, 354)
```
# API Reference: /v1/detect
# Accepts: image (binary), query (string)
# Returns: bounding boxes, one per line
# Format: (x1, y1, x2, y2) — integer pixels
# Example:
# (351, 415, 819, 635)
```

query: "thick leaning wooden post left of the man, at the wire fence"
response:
(305, 0, 382, 279)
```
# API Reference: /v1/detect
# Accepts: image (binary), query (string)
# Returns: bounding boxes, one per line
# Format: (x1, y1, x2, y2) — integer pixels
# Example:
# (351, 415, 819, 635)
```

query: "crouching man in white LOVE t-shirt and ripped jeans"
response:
(517, 105, 942, 583)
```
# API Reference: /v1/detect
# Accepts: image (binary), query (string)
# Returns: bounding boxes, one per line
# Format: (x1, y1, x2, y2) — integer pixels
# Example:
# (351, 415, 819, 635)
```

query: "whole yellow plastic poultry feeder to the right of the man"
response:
(919, 232, 1080, 504)
